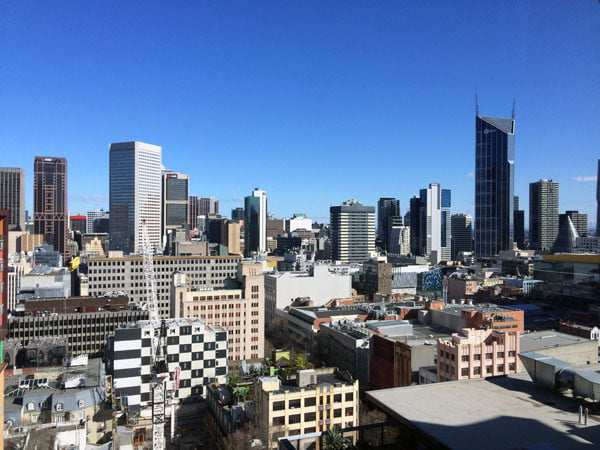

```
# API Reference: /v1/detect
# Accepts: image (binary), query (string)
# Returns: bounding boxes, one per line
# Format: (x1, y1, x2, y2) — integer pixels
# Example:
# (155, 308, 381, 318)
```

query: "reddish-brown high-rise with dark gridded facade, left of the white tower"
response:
(33, 156, 68, 262)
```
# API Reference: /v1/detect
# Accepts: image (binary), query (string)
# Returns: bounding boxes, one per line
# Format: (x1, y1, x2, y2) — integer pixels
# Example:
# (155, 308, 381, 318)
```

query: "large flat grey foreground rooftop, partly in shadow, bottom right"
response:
(366, 366, 600, 449)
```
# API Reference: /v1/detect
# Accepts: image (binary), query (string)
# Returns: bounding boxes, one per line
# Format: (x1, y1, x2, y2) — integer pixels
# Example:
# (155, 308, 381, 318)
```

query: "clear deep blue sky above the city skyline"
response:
(0, 0, 600, 223)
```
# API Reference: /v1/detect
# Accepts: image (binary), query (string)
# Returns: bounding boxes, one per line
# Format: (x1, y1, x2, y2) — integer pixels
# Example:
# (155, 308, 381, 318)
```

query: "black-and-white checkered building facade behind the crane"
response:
(108, 319, 227, 409)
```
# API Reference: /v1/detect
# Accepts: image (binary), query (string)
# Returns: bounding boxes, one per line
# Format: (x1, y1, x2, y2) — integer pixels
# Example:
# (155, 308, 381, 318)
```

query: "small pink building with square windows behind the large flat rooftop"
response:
(437, 328, 519, 381)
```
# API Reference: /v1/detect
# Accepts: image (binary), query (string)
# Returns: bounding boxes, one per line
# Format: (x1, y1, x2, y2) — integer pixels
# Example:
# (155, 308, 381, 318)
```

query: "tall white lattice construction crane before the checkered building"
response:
(142, 219, 169, 450)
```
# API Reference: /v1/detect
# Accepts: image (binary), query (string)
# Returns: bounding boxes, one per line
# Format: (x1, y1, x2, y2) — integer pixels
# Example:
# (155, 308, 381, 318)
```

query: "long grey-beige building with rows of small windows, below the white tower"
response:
(88, 252, 242, 318)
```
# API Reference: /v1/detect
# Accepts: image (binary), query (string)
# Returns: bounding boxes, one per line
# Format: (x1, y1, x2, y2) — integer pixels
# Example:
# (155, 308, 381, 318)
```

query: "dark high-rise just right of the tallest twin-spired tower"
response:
(529, 180, 558, 250)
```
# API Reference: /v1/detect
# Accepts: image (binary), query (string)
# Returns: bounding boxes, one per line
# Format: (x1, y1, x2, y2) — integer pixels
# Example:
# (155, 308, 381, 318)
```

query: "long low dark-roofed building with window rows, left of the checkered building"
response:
(8, 297, 148, 356)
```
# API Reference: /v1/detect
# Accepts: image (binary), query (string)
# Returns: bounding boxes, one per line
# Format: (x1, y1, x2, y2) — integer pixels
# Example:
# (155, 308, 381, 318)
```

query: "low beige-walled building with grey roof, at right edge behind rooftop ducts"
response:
(520, 330, 598, 365)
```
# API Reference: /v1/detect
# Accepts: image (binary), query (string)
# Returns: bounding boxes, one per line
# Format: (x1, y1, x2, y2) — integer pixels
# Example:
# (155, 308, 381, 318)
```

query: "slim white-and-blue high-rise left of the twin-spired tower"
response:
(419, 183, 451, 264)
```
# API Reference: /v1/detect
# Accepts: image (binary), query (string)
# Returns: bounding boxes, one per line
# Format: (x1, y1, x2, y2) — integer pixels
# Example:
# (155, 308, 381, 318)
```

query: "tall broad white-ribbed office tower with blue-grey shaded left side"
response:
(109, 142, 162, 254)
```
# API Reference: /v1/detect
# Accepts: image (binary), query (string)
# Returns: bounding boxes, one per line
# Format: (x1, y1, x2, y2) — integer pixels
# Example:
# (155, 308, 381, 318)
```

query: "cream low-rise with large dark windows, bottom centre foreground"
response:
(254, 368, 359, 448)
